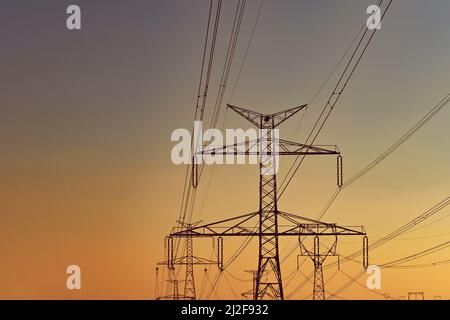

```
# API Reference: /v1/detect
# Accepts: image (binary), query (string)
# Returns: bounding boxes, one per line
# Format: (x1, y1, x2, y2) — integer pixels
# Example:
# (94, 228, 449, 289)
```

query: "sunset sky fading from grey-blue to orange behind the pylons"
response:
(0, 0, 450, 299)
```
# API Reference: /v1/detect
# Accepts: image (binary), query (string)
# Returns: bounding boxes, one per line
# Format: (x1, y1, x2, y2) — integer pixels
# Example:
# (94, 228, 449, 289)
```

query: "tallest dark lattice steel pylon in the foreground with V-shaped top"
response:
(168, 105, 366, 300)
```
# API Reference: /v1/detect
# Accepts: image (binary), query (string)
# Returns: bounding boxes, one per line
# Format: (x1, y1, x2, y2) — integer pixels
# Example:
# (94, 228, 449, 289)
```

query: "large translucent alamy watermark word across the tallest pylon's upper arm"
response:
(171, 121, 279, 175)
